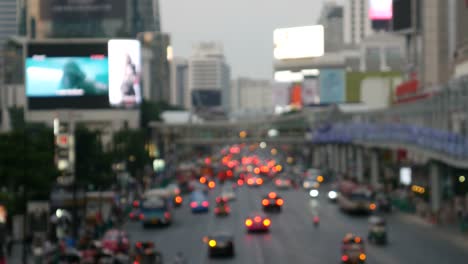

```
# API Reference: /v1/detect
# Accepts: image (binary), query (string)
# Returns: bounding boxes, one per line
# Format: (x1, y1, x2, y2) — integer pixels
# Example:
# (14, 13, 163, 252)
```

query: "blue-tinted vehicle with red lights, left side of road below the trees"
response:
(140, 197, 172, 228)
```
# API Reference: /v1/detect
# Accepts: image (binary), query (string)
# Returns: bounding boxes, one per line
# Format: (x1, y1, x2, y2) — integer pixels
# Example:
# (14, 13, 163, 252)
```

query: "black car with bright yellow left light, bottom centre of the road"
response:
(203, 233, 235, 258)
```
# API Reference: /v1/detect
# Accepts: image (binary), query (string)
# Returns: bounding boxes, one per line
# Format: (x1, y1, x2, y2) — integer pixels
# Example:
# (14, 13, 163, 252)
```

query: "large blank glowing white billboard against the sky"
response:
(273, 25, 325, 60)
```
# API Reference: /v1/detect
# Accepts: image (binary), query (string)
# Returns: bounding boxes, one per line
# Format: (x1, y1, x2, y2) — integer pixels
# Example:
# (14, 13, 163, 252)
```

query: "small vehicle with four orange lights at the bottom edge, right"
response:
(341, 234, 367, 264)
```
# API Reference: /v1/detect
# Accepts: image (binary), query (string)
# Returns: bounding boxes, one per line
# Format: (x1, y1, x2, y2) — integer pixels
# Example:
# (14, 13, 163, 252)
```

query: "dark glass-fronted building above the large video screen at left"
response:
(22, 0, 161, 39)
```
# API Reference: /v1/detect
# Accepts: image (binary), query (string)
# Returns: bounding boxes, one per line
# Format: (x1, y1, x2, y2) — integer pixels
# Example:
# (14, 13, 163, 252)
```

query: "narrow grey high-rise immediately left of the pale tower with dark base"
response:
(170, 57, 190, 108)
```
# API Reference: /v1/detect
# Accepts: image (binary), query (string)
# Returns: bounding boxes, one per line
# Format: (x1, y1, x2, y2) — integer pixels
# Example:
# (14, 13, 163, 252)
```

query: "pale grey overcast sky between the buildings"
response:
(160, 0, 332, 79)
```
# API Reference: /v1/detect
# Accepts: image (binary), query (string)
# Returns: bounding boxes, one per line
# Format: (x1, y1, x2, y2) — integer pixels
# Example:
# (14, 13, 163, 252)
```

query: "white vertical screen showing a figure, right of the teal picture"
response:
(108, 39, 141, 107)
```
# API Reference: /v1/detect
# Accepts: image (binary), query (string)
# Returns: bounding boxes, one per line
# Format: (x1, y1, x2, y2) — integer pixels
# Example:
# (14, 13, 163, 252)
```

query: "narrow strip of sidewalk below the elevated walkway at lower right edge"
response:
(395, 210, 468, 251)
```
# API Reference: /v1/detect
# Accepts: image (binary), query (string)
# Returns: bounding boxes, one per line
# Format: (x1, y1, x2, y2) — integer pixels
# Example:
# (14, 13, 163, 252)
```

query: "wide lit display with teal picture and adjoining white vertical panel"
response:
(25, 40, 141, 110)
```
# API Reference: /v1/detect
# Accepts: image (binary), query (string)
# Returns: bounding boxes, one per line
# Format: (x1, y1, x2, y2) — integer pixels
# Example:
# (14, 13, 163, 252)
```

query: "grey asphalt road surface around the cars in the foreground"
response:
(125, 183, 468, 264)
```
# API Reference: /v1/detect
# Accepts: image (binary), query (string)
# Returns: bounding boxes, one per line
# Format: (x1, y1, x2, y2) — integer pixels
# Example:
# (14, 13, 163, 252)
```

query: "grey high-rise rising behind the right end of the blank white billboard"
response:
(318, 1, 343, 52)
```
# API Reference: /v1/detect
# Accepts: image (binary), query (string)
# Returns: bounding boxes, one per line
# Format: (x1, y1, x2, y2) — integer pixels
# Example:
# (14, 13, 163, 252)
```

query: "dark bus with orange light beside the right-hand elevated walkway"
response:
(337, 181, 377, 213)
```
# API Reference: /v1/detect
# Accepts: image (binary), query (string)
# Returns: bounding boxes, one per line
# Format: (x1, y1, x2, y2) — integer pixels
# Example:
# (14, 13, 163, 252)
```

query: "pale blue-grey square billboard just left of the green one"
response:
(319, 69, 346, 104)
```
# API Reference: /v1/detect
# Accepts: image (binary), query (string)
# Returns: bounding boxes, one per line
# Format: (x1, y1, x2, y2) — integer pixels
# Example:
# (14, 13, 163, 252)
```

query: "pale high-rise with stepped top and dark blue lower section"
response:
(188, 42, 230, 112)
